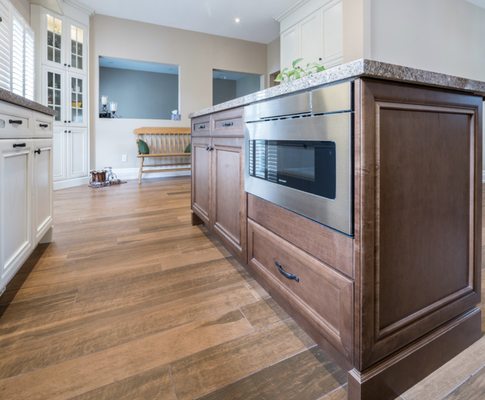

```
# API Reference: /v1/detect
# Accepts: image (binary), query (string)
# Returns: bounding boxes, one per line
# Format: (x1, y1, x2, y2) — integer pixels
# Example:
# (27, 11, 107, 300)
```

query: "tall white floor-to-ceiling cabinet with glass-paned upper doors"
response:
(31, 5, 89, 188)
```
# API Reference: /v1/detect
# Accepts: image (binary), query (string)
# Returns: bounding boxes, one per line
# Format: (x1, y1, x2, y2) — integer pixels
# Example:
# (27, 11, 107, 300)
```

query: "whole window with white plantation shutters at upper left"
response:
(0, 0, 34, 100)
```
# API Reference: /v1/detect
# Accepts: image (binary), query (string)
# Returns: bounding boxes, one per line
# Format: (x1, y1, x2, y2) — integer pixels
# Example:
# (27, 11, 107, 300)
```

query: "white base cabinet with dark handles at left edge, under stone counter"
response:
(0, 102, 53, 293)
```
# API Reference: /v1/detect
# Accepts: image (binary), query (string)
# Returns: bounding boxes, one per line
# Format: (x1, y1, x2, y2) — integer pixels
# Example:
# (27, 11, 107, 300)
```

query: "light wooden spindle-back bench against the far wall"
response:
(134, 127, 191, 183)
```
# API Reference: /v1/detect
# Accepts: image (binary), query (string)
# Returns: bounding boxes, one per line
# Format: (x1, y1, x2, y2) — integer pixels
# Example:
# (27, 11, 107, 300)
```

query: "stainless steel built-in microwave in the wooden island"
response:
(245, 82, 353, 235)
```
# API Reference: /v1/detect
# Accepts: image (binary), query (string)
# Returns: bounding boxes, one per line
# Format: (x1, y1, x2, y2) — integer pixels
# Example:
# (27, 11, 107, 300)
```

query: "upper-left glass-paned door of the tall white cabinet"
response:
(42, 14, 66, 68)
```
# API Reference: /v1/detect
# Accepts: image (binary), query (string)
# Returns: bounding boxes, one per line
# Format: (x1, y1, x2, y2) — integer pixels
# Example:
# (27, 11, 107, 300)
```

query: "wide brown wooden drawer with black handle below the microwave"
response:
(248, 220, 354, 361)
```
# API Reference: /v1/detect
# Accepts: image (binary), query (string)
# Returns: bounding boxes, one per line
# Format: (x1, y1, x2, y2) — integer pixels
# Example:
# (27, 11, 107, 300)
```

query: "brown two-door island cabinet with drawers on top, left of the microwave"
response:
(192, 109, 247, 261)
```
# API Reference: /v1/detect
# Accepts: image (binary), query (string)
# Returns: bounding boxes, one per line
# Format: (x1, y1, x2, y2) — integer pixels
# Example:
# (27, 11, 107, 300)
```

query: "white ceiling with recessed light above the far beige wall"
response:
(76, 0, 298, 43)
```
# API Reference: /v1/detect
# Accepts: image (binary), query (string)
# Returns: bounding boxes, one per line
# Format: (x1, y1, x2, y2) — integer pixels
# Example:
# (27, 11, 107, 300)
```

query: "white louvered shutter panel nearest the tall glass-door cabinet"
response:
(11, 12, 34, 100)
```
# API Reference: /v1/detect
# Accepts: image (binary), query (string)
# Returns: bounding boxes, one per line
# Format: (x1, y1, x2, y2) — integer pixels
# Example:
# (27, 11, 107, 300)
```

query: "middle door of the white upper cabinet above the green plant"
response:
(300, 10, 323, 65)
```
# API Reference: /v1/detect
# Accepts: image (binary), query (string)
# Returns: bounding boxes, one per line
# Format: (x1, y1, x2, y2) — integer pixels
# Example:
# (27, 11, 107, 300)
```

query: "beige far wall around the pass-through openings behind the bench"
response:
(90, 15, 267, 168)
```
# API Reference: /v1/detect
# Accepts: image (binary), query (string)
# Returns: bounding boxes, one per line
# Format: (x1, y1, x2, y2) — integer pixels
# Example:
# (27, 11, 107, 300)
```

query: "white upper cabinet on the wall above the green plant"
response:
(280, 0, 343, 69)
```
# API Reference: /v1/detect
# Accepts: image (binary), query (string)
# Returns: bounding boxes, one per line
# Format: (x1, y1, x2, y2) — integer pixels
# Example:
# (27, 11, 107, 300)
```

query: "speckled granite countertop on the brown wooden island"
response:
(189, 59, 485, 118)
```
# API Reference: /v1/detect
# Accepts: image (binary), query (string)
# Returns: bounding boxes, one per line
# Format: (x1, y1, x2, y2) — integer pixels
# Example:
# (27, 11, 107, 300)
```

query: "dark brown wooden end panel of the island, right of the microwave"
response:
(356, 80, 482, 369)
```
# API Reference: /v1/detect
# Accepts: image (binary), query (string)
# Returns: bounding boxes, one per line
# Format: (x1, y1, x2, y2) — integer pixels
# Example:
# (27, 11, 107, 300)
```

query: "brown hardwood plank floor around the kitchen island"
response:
(0, 178, 485, 400)
